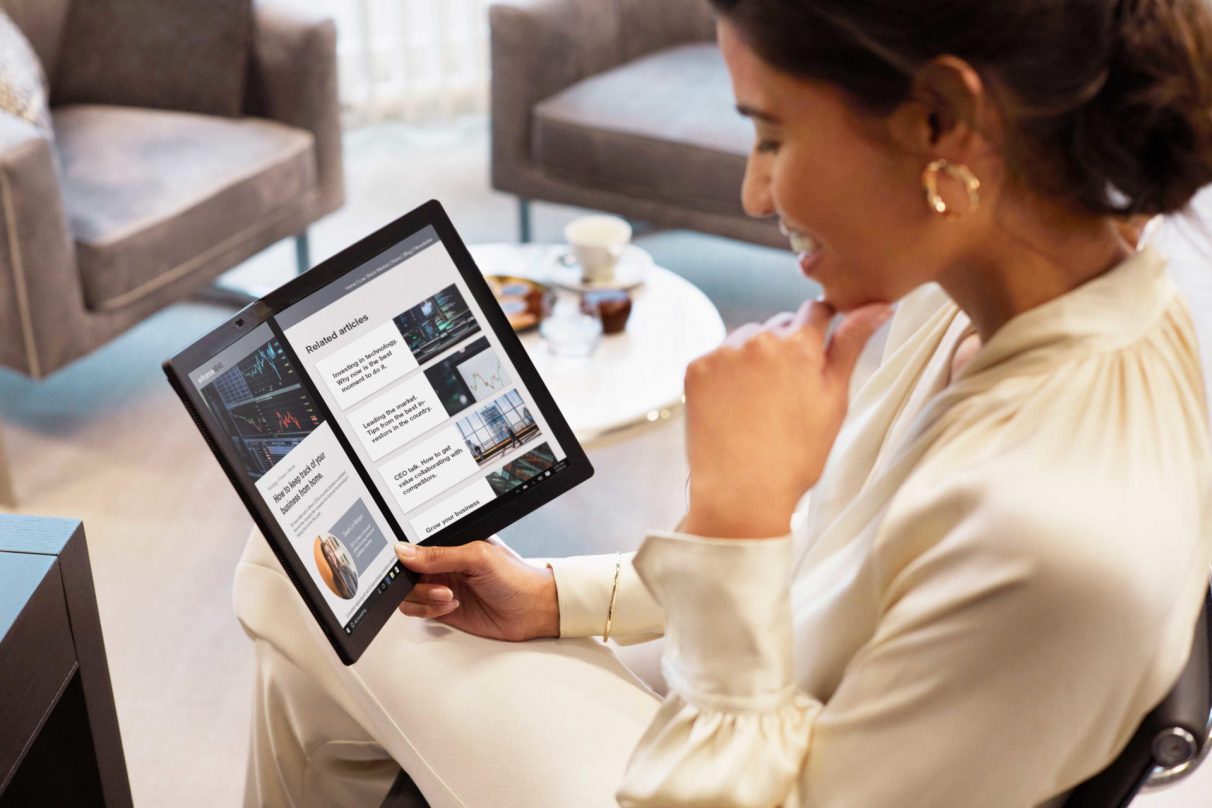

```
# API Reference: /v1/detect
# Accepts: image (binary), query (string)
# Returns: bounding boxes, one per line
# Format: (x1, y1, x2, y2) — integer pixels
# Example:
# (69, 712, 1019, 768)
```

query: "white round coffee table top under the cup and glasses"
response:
(469, 243, 725, 441)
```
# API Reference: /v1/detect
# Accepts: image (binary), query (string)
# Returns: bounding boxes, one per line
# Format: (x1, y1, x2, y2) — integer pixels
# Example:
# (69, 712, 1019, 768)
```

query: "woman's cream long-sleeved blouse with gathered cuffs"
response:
(553, 248, 1212, 808)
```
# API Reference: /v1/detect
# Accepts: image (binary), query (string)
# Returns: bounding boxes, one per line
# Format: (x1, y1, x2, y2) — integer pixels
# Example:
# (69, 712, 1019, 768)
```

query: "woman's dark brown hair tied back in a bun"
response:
(710, 0, 1212, 216)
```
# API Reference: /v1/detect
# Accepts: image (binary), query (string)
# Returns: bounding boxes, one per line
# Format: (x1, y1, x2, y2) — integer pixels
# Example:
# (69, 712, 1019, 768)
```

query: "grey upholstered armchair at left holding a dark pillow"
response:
(0, 0, 344, 380)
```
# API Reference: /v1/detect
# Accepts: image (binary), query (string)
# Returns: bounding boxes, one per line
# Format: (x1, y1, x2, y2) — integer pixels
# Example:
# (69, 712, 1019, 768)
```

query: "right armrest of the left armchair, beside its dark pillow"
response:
(245, 0, 345, 216)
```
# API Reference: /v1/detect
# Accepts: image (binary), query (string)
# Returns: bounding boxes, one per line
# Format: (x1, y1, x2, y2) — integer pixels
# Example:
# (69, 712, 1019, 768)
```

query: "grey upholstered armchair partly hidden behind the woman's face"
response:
(490, 0, 787, 246)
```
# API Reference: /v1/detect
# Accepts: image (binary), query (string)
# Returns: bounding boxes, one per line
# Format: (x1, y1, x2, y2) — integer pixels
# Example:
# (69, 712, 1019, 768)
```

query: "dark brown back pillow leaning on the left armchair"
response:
(51, 0, 252, 118)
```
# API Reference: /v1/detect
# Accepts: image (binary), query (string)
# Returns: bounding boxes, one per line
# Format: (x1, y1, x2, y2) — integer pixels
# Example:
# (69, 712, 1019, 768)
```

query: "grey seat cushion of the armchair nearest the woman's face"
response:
(531, 42, 753, 213)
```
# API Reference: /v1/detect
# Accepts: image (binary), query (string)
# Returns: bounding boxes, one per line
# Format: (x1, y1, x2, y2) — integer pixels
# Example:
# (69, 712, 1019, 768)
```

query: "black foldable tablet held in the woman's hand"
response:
(164, 201, 593, 665)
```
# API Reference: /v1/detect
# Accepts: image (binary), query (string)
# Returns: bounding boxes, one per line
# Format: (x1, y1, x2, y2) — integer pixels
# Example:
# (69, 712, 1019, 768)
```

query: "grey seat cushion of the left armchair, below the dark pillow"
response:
(52, 105, 315, 310)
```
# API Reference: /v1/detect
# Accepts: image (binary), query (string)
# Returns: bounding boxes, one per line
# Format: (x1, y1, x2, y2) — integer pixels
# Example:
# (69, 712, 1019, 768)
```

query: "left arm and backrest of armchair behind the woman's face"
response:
(488, 0, 715, 188)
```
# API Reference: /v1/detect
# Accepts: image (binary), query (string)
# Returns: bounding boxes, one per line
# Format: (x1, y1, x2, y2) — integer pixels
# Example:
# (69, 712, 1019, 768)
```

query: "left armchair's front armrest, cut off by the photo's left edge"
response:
(0, 113, 84, 377)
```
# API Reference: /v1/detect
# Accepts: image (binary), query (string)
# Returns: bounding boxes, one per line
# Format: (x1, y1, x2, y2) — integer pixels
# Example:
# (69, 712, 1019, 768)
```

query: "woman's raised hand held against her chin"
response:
(682, 300, 891, 539)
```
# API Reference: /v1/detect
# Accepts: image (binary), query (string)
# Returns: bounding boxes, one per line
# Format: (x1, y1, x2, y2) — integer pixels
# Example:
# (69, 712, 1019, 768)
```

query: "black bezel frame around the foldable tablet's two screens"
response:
(164, 200, 594, 665)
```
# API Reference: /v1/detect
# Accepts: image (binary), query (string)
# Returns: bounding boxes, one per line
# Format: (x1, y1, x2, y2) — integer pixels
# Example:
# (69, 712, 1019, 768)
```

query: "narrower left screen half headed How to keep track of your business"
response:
(190, 325, 401, 634)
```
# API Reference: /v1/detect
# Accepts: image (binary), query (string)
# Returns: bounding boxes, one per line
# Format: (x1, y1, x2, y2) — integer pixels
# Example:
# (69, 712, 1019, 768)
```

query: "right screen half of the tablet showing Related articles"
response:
(278, 228, 567, 541)
